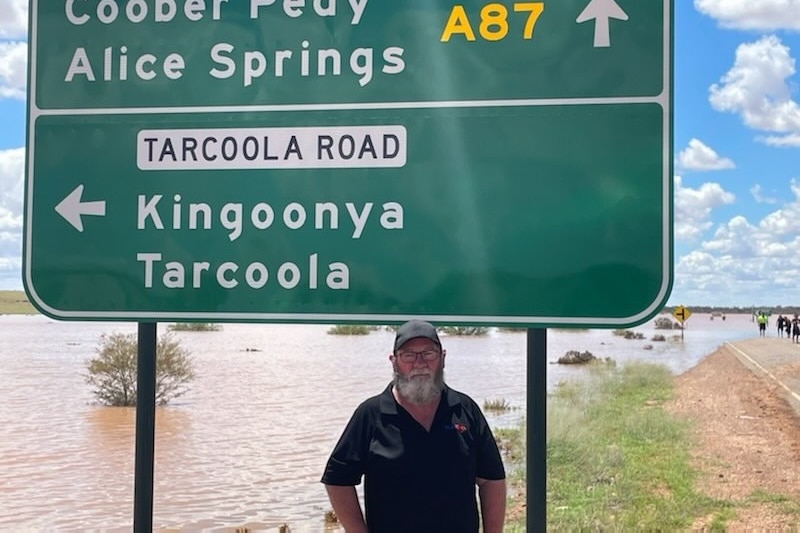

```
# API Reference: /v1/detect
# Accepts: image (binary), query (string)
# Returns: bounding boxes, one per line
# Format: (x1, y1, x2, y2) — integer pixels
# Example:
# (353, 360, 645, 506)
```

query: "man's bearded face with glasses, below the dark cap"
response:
(390, 337, 446, 404)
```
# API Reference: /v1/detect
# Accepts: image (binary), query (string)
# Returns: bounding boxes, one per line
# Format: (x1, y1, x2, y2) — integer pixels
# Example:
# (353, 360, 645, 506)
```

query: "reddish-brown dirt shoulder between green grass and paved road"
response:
(667, 339, 800, 531)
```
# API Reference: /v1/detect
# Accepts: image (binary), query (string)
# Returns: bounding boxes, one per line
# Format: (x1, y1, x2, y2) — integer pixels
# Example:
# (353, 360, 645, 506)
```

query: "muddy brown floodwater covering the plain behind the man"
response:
(0, 314, 760, 532)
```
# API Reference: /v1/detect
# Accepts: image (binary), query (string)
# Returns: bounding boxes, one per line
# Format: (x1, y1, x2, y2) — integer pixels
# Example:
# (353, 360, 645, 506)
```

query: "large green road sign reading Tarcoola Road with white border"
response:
(24, 0, 672, 326)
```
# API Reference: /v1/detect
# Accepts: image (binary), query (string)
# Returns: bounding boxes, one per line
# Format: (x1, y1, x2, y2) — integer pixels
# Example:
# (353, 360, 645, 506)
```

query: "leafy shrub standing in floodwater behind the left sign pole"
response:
(86, 333, 195, 406)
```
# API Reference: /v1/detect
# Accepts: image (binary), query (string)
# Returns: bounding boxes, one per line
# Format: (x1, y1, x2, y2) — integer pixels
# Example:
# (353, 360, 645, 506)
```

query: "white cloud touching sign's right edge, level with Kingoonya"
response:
(674, 176, 736, 241)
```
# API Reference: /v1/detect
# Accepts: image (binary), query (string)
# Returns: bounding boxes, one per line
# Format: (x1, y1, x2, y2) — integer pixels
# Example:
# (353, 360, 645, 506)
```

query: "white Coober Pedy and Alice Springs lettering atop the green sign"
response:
(64, 0, 405, 87)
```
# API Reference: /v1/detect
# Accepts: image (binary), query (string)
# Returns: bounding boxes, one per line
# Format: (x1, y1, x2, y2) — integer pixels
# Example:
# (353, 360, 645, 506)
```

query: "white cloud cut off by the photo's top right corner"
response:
(694, 0, 800, 31)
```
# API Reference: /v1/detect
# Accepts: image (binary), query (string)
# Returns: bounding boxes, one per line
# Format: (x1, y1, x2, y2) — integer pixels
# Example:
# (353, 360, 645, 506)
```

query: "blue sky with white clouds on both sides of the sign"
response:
(0, 0, 800, 307)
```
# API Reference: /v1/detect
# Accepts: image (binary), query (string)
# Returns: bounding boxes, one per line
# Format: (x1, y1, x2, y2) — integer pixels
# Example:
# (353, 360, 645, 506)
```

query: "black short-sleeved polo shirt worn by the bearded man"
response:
(322, 384, 505, 533)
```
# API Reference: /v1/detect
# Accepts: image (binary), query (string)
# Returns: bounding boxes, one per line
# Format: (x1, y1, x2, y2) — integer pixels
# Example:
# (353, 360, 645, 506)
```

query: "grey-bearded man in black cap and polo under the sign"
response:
(322, 320, 506, 533)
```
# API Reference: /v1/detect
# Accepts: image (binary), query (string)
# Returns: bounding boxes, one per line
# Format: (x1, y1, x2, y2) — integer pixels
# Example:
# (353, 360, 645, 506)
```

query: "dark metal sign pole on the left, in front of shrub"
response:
(133, 322, 157, 533)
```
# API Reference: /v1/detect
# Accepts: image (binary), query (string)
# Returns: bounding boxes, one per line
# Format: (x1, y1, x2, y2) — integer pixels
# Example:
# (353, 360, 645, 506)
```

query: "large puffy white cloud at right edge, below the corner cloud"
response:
(709, 35, 800, 133)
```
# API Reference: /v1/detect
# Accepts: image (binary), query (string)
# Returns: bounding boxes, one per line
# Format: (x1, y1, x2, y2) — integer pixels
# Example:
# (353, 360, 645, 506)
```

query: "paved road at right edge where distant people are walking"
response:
(725, 337, 800, 413)
